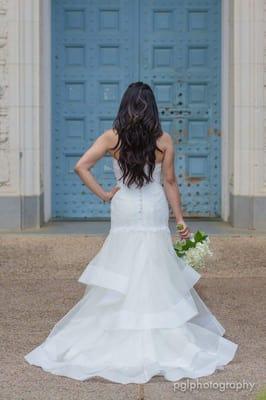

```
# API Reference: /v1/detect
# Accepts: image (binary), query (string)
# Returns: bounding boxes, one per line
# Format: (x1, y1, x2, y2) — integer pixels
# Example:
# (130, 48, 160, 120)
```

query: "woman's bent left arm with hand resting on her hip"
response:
(74, 130, 119, 201)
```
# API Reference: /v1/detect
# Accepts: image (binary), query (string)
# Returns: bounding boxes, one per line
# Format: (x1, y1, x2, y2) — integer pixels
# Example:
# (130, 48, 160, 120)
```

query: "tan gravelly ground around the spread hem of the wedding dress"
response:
(0, 235, 266, 400)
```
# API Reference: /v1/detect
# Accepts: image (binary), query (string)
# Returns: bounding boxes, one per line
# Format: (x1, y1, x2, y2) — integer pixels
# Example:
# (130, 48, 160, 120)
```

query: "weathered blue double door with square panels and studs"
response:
(52, 0, 221, 219)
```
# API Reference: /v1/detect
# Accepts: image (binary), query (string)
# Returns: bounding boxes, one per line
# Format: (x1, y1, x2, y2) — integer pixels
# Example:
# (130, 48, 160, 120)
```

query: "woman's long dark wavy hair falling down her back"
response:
(112, 82, 163, 187)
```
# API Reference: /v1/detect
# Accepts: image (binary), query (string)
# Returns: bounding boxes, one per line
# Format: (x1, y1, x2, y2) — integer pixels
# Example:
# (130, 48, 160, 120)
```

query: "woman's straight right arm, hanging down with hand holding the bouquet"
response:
(162, 132, 190, 239)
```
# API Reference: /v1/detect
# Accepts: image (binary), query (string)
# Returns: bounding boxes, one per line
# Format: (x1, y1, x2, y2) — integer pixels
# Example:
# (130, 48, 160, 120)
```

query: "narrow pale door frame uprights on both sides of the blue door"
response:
(40, 0, 231, 222)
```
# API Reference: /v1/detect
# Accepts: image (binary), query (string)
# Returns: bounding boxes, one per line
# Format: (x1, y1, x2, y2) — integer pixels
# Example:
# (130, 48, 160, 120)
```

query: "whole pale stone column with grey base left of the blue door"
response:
(0, 0, 50, 230)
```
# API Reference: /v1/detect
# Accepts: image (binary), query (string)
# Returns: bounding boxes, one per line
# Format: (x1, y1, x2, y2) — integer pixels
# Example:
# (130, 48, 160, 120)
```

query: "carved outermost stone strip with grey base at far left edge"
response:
(0, 0, 20, 228)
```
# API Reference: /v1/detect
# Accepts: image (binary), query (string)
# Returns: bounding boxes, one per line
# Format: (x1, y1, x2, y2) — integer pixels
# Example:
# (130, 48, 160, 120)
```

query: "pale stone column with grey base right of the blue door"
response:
(228, 0, 266, 229)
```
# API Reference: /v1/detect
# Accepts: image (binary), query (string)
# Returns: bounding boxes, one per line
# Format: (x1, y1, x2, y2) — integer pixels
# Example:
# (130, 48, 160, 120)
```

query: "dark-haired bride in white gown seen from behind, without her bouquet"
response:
(24, 82, 238, 384)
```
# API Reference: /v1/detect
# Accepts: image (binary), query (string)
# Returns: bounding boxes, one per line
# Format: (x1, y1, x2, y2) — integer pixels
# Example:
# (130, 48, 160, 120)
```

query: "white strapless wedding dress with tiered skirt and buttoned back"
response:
(24, 158, 238, 384)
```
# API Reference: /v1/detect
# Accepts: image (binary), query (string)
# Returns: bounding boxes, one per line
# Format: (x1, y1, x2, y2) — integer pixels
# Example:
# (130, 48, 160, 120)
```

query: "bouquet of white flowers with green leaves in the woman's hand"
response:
(174, 224, 213, 270)
